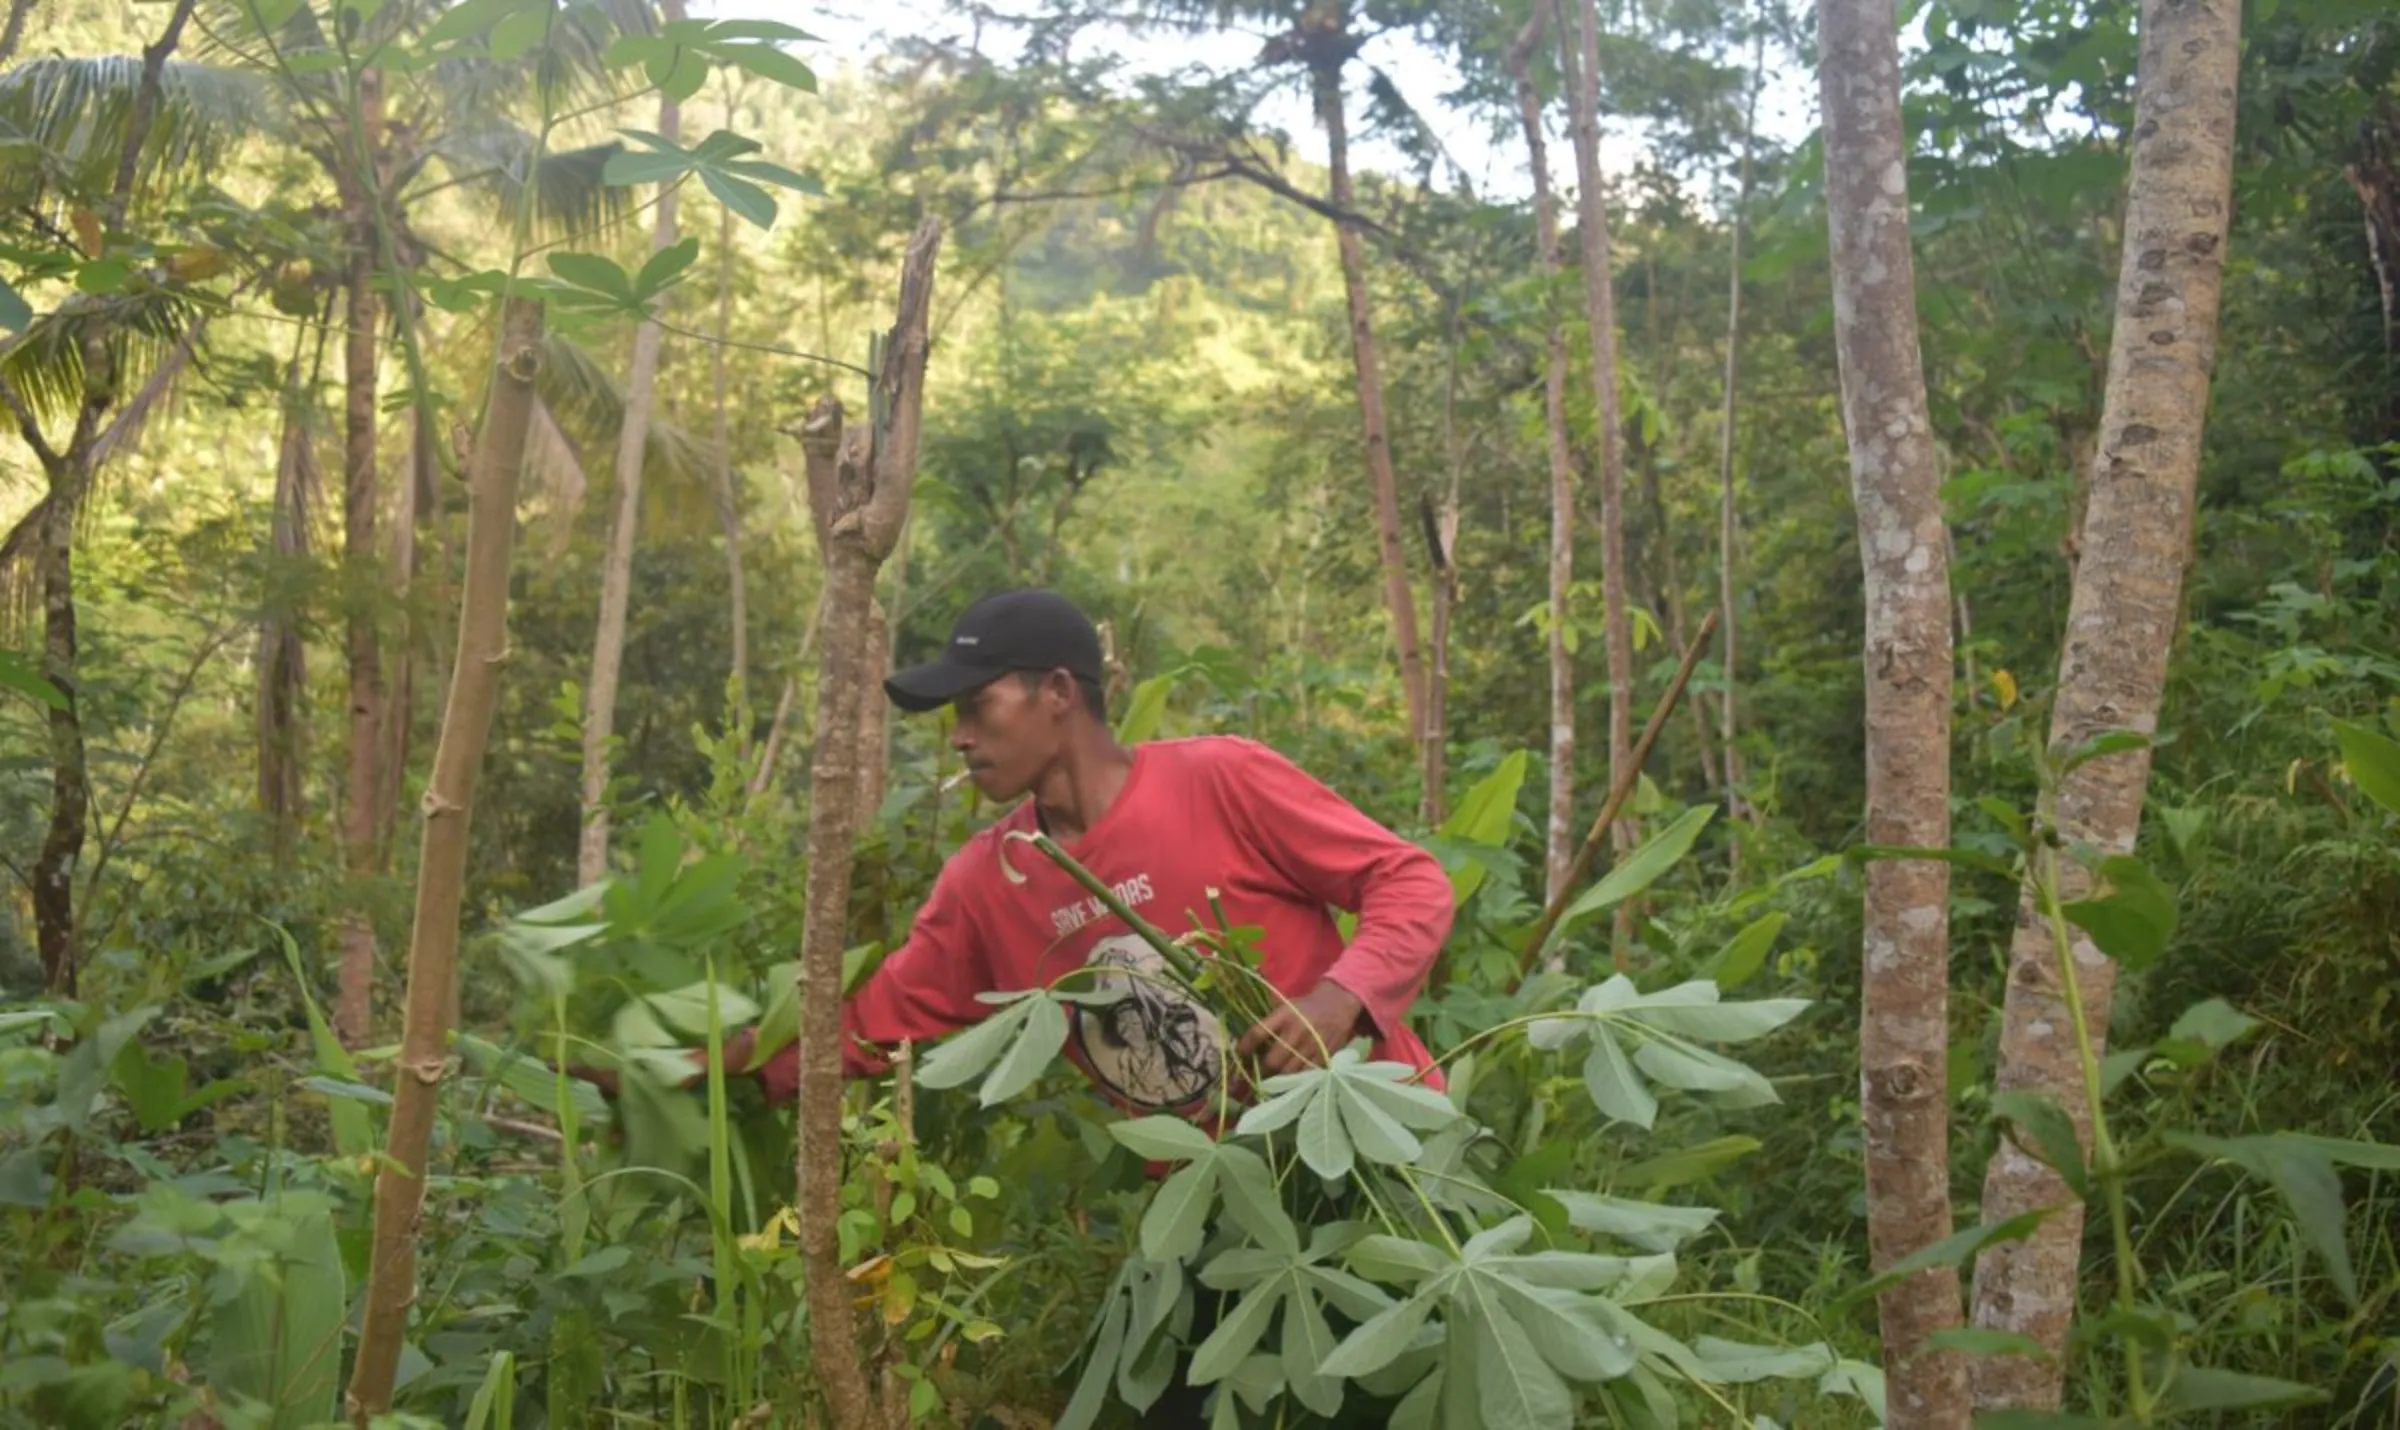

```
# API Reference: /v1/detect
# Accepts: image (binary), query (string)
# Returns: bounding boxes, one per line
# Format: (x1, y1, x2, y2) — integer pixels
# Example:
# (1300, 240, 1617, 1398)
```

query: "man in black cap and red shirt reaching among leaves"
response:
(727, 590, 1452, 1120)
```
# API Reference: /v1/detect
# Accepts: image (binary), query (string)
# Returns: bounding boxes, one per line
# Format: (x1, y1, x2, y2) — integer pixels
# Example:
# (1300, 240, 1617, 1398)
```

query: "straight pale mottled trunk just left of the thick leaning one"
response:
(1817, 0, 1968, 1430)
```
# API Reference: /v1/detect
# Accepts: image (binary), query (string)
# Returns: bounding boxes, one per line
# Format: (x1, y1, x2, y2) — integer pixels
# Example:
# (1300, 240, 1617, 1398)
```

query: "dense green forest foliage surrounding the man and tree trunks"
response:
(0, 0, 2400, 1430)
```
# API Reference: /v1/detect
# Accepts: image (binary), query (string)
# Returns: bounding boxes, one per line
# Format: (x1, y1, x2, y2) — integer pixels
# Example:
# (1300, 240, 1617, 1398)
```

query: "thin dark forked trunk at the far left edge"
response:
(0, 0, 194, 998)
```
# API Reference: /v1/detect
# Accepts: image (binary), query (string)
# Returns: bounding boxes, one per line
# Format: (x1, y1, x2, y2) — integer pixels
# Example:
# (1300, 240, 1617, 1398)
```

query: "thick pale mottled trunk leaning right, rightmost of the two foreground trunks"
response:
(1973, 0, 2242, 1408)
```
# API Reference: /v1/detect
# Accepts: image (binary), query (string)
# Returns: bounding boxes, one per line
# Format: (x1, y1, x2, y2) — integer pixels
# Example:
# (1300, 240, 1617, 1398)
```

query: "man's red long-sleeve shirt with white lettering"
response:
(761, 737, 1452, 1120)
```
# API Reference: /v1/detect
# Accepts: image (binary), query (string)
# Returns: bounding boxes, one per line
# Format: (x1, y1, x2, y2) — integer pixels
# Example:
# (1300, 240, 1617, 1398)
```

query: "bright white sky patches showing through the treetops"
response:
(694, 0, 1817, 199)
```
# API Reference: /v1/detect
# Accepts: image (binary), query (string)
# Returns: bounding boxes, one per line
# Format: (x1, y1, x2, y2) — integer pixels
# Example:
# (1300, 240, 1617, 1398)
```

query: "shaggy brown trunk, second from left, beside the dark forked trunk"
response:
(257, 346, 317, 866)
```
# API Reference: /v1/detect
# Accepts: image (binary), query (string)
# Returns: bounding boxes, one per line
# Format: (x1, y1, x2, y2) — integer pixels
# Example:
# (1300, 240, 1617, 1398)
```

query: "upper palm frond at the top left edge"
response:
(0, 55, 281, 209)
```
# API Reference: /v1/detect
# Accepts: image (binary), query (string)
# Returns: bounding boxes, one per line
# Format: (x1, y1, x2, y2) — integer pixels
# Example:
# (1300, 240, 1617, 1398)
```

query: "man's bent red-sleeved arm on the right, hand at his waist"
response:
(1217, 739, 1454, 1073)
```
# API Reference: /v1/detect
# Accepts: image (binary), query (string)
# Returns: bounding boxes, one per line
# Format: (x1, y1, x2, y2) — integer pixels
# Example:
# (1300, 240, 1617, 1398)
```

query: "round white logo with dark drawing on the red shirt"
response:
(1070, 933, 1224, 1111)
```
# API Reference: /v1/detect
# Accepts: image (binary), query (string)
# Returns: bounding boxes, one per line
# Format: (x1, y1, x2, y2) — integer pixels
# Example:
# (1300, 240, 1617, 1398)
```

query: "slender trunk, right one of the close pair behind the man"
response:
(1558, 0, 1642, 887)
